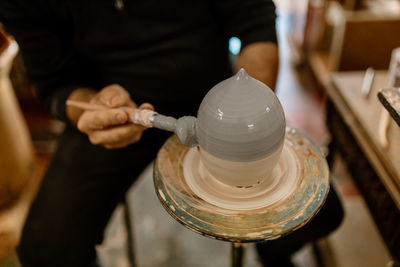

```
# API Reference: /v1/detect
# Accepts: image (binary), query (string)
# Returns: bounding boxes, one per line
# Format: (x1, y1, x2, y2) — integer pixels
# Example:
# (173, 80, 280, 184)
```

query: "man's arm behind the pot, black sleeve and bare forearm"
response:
(211, 0, 279, 89)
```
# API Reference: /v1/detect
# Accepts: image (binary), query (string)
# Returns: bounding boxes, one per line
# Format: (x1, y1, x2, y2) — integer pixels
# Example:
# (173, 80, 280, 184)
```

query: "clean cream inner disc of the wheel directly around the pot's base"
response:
(183, 141, 303, 213)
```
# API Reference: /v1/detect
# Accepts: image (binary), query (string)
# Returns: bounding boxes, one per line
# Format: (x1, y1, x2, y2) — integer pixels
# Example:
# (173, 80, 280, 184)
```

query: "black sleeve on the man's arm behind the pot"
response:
(210, 0, 277, 47)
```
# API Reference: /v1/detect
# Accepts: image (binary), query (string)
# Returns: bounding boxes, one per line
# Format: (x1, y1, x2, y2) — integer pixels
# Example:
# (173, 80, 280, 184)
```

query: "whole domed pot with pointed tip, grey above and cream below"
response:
(197, 69, 285, 187)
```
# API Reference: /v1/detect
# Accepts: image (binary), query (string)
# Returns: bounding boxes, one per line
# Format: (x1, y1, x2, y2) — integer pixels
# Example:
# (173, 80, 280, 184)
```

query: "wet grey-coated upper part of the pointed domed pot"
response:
(197, 69, 285, 161)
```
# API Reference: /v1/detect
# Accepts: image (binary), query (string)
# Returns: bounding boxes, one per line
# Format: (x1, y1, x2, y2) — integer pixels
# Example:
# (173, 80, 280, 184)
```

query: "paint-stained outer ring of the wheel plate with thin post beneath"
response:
(154, 127, 329, 267)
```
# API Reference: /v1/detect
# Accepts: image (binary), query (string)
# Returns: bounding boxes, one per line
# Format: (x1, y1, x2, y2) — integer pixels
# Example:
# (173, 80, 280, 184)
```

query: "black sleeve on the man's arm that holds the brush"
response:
(0, 0, 94, 121)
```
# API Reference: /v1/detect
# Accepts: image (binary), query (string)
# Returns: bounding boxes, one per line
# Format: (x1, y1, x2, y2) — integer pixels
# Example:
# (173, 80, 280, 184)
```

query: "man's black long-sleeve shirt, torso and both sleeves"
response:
(0, 0, 276, 120)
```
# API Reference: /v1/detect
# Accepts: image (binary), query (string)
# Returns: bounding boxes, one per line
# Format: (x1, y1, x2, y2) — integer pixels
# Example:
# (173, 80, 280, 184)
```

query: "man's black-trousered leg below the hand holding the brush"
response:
(18, 128, 168, 266)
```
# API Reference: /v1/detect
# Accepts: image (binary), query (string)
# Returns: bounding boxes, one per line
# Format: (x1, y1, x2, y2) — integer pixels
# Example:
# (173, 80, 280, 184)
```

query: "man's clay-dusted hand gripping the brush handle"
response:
(67, 85, 149, 149)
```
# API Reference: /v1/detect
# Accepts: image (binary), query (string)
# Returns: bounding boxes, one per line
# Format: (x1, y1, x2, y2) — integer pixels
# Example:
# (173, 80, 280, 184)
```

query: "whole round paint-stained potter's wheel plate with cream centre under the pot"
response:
(154, 127, 329, 242)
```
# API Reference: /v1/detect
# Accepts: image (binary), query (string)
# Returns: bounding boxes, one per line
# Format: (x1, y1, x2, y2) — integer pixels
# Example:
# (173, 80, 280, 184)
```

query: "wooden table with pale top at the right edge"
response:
(324, 71, 400, 261)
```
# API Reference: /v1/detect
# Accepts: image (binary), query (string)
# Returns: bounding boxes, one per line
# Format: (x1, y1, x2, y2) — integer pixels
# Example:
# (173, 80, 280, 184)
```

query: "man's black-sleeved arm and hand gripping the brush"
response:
(0, 0, 150, 148)
